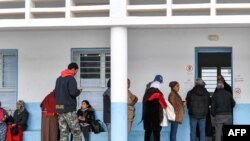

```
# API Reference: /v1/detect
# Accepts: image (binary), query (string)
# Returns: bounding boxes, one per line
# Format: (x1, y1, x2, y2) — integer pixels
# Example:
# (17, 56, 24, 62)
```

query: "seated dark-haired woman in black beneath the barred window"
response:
(77, 100, 95, 141)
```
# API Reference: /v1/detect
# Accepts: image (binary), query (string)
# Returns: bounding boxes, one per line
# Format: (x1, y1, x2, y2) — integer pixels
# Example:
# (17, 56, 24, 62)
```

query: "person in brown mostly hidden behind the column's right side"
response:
(128, 79, 138, 133)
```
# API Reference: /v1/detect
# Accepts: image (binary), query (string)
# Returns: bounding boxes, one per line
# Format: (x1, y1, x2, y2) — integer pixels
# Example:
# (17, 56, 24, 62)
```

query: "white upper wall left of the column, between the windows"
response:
(0, 29, 110, 102)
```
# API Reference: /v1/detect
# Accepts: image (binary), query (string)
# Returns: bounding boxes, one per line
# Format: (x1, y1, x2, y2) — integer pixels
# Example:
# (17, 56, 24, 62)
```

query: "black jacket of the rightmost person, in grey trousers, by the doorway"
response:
(211, 89, 235, 116)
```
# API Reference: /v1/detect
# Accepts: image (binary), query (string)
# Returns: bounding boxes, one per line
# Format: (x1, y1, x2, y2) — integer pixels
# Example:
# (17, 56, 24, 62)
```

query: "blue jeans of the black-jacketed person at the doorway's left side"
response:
(190, 117, 206, 141)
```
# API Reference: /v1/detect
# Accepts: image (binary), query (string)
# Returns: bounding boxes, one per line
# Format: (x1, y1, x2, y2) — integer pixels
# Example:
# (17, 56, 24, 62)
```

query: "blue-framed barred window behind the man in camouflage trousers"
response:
(72, 48, 110, 110)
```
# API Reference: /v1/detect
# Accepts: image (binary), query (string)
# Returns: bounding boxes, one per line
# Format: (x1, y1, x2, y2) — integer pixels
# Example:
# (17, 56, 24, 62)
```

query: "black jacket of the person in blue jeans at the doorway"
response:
(186, 85, 210, 119)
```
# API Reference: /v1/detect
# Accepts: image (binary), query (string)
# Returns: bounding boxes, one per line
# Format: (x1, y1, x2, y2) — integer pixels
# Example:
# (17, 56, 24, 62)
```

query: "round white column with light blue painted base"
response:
(111, 27, 128, 141)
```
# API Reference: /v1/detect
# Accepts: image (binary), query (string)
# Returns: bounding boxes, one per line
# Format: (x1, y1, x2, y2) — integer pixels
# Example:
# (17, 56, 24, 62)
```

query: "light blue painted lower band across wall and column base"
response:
(24, 102, 250, 141)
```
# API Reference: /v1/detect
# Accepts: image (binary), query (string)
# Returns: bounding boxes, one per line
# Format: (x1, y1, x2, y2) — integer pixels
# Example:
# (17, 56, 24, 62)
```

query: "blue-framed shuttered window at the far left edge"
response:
(0, 50, 17, 109)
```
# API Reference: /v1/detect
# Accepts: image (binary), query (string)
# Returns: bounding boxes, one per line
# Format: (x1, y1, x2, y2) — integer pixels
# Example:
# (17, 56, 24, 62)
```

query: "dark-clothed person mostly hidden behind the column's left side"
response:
(103, 79, 111, 141)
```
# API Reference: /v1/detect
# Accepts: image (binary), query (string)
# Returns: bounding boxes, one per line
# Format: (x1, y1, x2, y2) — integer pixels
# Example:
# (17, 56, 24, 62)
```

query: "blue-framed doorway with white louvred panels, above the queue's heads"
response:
(195, 47, 233, 93)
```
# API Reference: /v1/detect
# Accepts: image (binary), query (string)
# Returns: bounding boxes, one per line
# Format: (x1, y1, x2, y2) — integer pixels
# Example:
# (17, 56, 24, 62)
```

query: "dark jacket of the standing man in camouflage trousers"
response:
(55, 76, 81, 113)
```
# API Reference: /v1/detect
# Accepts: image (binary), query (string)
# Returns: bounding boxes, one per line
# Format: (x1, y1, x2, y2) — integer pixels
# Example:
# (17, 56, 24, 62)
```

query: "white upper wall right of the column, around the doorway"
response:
(128, 28, 250, 103)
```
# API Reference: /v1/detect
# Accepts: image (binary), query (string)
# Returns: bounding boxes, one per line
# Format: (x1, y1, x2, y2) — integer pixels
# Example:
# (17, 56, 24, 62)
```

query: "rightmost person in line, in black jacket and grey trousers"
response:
(211, 82, 235, 141)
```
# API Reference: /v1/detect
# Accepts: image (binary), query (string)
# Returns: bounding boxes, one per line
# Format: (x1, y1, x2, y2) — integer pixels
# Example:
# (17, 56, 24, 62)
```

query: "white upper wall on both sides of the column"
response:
(0, 28, 250, 103)
